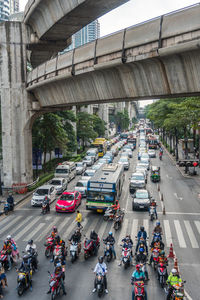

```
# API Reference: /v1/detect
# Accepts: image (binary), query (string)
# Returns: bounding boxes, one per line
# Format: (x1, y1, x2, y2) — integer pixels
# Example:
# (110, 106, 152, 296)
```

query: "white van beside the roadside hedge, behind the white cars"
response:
(54, 161, 76, 182)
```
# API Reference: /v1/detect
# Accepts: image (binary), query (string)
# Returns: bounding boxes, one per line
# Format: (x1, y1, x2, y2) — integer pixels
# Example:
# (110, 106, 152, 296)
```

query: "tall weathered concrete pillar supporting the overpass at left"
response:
(0, 22, 33, 187)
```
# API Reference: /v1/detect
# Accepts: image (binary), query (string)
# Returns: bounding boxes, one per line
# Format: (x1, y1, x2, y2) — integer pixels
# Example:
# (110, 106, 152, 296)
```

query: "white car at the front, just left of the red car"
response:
(31, 184, 56, 206)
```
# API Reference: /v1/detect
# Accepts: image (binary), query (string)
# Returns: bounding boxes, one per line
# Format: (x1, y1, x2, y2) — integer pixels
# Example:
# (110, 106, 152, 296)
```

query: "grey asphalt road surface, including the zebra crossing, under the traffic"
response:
(0, 144, 200, 300)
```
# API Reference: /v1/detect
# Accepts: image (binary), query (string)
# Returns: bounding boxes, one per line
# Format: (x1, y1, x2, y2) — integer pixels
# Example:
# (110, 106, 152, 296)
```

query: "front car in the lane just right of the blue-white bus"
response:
(132, 189, 151, 210)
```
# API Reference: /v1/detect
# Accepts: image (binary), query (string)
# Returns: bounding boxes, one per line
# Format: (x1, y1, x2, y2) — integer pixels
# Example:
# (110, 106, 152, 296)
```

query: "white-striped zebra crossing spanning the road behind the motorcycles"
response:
(0, 216, 200, 249)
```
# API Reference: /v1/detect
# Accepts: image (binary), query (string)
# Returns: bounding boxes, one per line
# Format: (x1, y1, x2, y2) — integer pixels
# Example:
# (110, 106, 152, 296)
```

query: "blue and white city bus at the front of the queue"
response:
(86, 163, 124, 212)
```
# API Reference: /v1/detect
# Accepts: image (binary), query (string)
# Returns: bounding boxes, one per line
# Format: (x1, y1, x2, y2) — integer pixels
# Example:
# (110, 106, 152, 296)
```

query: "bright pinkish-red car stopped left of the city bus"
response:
(56, 191, 81, 212)
